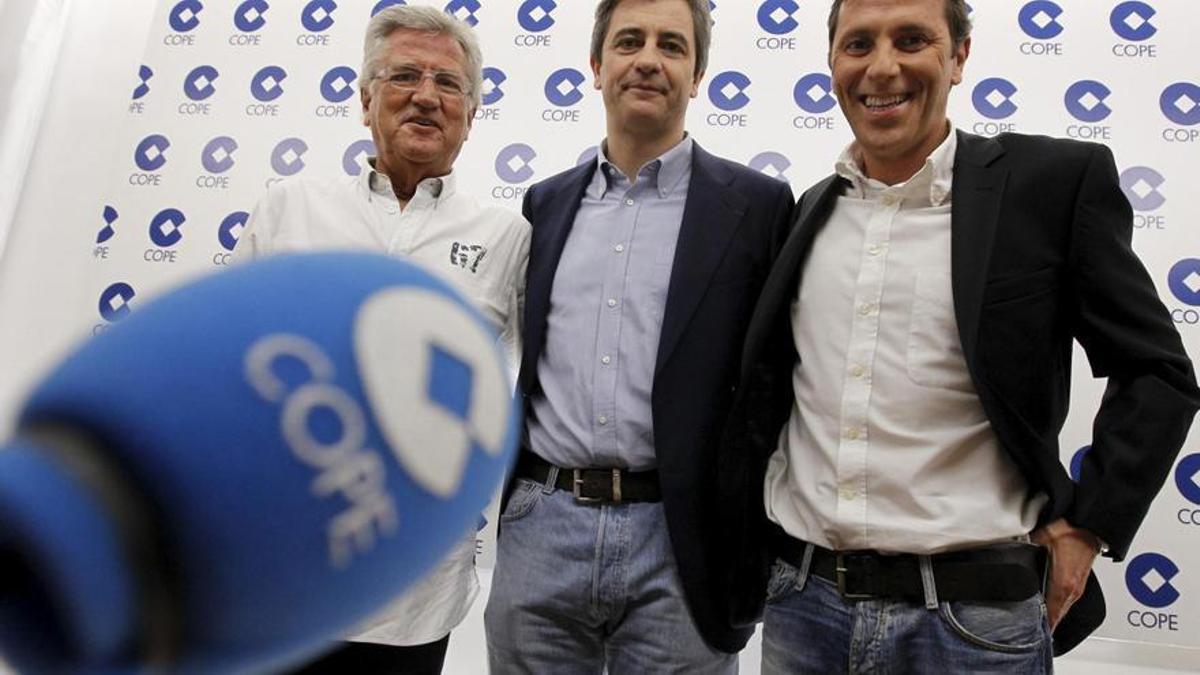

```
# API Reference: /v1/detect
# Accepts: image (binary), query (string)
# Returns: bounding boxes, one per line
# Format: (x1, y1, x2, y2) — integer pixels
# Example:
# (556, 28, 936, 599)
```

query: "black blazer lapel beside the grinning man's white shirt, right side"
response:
(950, 131, 1008, 364)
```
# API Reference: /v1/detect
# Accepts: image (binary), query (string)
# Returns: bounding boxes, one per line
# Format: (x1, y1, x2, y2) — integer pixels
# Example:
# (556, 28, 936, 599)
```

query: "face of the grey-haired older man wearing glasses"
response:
(361, 29, 473, 178)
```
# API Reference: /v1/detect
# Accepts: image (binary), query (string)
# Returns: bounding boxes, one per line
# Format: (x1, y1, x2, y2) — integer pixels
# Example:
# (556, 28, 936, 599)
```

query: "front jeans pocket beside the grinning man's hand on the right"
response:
(938, 596, 1050, 653)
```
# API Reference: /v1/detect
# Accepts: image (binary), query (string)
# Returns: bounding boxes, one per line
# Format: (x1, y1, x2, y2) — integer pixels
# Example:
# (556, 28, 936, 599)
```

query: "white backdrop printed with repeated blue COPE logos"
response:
(0, 0, 1200, 662)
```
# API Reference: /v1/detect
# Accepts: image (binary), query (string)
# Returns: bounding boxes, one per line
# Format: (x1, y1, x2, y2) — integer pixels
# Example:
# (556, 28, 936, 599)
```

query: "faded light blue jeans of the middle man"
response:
(484, 470, 737, 675)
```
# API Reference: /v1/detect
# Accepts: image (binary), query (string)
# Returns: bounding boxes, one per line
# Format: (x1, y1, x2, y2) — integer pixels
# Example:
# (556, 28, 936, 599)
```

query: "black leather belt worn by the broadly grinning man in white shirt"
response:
(775, 536, 1045, 602)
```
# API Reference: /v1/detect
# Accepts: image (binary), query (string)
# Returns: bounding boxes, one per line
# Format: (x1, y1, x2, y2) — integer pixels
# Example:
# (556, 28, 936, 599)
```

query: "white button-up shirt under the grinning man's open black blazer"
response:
(764, 127, 1045, 552)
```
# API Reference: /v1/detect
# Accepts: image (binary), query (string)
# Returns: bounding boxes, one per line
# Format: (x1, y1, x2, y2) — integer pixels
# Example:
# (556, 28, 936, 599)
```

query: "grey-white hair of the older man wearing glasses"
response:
(359, 5, 484, 109)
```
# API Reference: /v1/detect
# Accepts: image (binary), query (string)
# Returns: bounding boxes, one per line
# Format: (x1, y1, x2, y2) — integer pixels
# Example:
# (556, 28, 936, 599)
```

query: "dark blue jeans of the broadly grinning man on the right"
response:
(762, 552, 1054, 675)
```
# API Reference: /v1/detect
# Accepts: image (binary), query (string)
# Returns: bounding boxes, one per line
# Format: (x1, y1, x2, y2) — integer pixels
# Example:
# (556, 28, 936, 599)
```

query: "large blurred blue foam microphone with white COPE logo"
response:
(0, 253, 518, 673)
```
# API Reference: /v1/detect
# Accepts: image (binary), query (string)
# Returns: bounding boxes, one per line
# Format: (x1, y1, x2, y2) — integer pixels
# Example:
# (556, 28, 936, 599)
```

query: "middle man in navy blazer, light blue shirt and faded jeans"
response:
(485, 0, 793, 673)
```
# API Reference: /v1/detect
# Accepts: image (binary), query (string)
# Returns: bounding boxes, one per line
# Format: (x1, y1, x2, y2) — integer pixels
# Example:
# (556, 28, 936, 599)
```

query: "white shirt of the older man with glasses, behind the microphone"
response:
(234, 165, 530, 645)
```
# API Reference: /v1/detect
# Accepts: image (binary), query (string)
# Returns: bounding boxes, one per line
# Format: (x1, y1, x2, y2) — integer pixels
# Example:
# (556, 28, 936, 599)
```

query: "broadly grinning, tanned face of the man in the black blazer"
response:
(829, 0, 971, 184)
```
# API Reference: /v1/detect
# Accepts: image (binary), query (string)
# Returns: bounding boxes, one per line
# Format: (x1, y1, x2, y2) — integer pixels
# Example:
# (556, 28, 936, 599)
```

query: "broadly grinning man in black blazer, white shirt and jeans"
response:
(718, 0, 1200, 673)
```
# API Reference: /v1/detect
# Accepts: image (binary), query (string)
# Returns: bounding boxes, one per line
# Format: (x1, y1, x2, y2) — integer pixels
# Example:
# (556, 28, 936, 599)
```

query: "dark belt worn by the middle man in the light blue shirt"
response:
(516, 450, 662, 504)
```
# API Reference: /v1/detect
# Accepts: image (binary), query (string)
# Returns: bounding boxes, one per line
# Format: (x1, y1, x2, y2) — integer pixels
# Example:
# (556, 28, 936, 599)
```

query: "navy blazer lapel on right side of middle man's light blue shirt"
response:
(654, 144, 745, 374)
